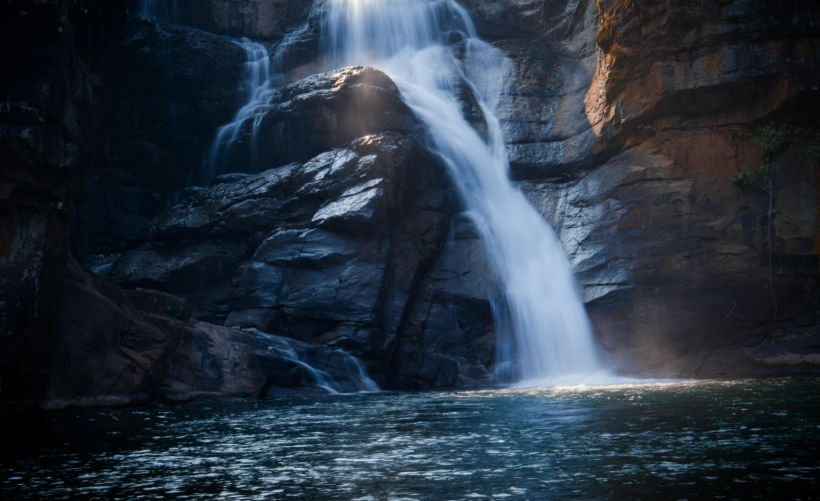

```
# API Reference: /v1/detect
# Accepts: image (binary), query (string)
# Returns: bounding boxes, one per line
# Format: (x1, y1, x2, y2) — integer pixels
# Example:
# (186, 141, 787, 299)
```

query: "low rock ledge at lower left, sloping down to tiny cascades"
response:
(42, 252, 374, 409)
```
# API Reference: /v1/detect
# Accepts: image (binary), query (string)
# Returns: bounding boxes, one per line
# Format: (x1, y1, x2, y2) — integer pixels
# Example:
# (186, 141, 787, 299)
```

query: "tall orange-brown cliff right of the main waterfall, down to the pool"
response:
(506, 0, 820, 376)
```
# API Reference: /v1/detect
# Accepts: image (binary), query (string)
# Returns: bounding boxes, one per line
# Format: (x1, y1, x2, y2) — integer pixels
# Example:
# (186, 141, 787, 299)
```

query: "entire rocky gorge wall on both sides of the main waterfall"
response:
(0, 0, 820, 407)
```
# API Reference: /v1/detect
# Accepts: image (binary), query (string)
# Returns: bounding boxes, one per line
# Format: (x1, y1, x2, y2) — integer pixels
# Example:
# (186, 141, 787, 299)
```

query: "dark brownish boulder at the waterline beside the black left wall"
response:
(43, 260, 177, 409)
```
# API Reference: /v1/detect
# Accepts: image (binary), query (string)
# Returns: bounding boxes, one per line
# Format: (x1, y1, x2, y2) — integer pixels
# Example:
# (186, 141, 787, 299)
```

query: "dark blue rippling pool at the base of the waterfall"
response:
(0, 379, 820, 500)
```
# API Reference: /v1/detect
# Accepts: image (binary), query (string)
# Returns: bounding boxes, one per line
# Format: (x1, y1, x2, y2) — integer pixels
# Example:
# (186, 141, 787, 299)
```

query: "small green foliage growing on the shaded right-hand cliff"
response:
(732, 120, 820, 189)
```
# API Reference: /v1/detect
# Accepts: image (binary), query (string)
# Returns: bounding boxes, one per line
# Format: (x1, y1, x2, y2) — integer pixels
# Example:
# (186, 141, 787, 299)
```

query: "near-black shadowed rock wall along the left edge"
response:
(0, 0, 126, 399)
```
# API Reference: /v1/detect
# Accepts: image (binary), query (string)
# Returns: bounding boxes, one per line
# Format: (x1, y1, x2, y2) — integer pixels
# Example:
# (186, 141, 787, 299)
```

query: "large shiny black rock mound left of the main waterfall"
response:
(108, 67, 500, 387)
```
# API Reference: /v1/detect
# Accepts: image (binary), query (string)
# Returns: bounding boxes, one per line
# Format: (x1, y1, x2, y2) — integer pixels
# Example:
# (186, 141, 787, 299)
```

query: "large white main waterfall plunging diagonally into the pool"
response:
(321, 0, 599, 380)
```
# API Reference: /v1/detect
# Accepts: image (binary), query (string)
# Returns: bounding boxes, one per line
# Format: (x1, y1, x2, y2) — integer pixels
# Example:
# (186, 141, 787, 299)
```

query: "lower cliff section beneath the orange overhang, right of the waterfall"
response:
(522, 131, 817, 377)
